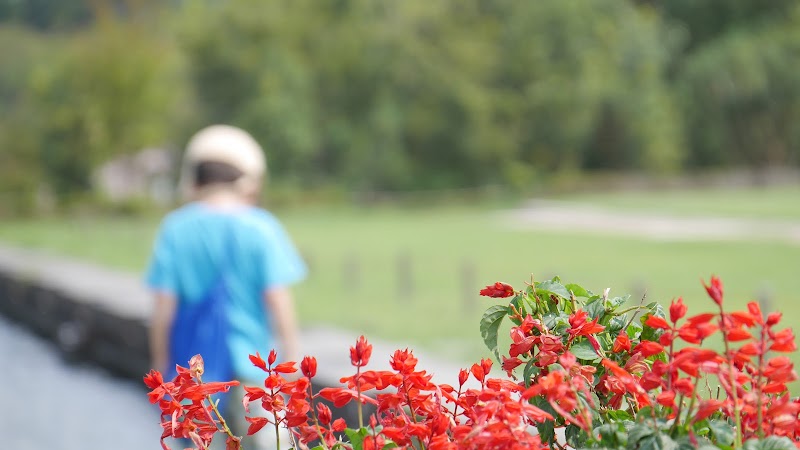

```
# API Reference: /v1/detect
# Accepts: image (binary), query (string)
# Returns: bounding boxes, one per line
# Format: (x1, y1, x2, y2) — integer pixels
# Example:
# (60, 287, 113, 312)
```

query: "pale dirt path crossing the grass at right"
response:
(499, 200, 800, 245)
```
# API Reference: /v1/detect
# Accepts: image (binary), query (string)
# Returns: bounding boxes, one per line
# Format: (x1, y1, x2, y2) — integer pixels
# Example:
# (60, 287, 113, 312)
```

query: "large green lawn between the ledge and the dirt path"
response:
(0, 196, 800, 368)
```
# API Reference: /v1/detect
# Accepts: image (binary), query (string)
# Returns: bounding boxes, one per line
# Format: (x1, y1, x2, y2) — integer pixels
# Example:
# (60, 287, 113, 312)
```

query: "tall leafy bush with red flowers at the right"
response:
(482, 277, 800, 448)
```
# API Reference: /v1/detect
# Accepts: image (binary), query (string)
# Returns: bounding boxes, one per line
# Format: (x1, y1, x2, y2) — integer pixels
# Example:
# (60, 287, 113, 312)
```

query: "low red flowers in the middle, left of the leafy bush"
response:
(245, 336, 552, 450)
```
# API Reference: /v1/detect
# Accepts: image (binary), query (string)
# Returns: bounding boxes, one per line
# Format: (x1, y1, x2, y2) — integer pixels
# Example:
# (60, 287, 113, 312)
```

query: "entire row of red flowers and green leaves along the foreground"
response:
(145, 277, 800, 450)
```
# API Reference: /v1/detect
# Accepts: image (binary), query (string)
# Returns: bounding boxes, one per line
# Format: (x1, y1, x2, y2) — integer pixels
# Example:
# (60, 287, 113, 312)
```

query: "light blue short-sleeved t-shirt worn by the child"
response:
(146, 202, 307, 381)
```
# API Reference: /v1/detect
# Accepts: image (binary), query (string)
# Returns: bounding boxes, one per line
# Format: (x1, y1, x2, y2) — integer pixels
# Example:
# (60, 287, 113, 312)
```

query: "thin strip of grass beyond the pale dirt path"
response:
(562, 185, 800, 221)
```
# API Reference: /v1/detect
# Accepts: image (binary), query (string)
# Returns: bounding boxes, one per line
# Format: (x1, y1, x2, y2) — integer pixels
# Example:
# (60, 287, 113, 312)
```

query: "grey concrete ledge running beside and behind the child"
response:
(0, 245, 476, 424)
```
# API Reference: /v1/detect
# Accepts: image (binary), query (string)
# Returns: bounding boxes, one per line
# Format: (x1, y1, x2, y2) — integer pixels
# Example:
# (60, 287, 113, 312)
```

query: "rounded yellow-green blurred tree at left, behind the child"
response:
(31, 20, 188, 200)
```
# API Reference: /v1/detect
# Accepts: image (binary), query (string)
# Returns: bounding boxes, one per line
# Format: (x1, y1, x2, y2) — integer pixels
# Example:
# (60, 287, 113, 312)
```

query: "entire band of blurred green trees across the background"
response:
(0, 0, 800, 211)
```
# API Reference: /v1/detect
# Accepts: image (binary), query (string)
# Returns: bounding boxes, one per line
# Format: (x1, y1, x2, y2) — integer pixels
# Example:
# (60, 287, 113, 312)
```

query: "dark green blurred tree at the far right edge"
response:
(680, 9, 800, 168)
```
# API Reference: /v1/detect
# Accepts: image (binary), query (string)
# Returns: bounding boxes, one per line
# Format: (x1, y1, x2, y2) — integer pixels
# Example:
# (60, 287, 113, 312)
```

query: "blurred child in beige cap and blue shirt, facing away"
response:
(146, 125, 306, 448)
